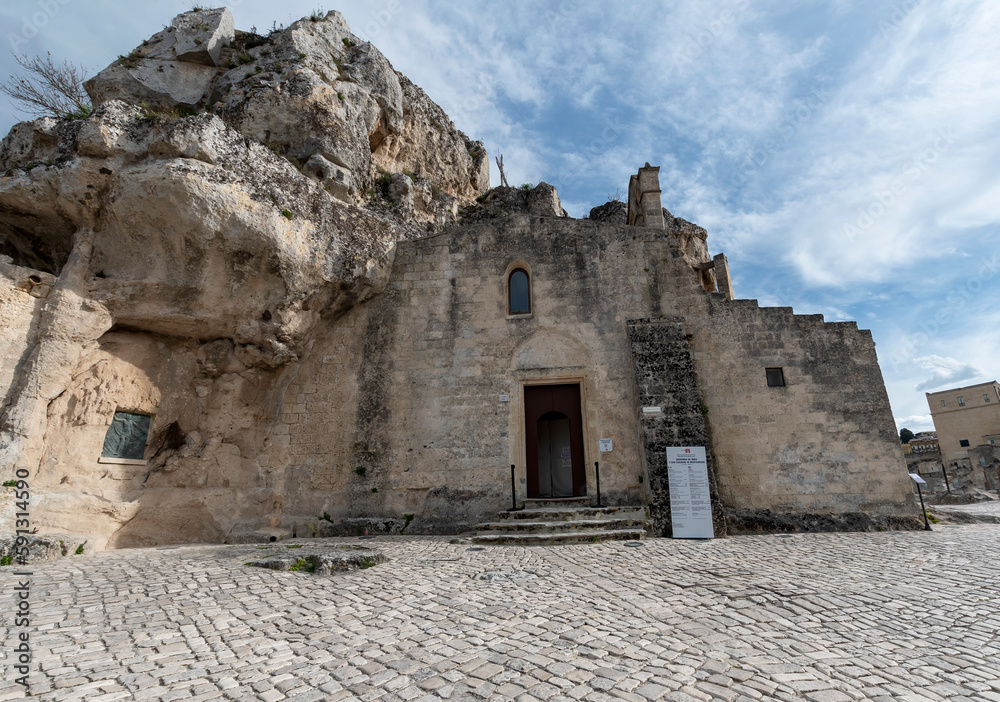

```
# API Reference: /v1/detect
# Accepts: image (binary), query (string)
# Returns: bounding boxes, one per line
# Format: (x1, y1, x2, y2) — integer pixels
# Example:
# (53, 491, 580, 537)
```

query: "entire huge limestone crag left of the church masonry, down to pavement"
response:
(0, 9, 489, 549)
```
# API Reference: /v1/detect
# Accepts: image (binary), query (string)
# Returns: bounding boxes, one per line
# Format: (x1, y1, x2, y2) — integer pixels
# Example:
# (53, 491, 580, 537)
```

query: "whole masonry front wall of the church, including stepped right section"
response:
(261, 215, 913, 534)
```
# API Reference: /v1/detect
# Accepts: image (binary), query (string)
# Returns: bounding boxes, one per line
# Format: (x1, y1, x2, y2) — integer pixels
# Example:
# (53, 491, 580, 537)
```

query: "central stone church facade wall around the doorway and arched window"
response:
(265, 215, 672, 531)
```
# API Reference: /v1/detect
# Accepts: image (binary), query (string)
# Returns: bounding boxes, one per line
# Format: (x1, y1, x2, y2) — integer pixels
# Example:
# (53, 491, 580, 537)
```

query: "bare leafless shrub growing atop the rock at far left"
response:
(0, 53, 93, 119)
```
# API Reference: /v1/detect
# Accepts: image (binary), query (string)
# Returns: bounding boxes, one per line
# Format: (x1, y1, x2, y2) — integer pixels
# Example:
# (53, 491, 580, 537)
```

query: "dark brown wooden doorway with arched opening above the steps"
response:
(524, 384, 587, 498)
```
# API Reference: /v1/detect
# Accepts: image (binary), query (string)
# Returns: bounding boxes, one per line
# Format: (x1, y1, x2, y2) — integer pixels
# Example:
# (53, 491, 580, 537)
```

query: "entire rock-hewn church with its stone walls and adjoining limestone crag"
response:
(0, 10, 913, 548)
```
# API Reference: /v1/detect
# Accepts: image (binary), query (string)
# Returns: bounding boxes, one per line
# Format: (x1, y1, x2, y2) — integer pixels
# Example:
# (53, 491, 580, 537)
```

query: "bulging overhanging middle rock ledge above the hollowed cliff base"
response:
(0, 101, 414, 352)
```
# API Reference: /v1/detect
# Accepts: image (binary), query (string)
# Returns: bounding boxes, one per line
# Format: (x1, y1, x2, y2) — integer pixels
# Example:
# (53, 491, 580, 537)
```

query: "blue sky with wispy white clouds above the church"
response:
(0, 0, 1000, 431)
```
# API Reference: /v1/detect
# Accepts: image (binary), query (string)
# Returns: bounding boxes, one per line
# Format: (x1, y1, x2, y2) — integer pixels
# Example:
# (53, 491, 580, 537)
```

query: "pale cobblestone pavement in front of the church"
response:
(0, 524, 1000, 702)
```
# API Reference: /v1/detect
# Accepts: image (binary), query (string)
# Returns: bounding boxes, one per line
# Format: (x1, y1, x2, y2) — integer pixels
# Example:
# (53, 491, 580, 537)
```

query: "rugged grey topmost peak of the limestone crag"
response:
(86, 9, 489, 208)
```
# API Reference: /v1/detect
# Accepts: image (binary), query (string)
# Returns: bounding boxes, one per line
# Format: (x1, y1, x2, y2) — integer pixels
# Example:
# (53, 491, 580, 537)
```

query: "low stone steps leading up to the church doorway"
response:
(463, 497, 649, 546)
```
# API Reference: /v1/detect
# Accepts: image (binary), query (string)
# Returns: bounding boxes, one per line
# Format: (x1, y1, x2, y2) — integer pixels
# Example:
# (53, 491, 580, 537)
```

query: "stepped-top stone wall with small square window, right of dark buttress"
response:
(686, 294, 914, 513)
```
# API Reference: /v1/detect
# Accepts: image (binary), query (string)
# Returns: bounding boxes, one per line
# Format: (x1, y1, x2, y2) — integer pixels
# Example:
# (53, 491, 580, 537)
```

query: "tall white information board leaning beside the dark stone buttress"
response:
(667, 446, 715, 539)
